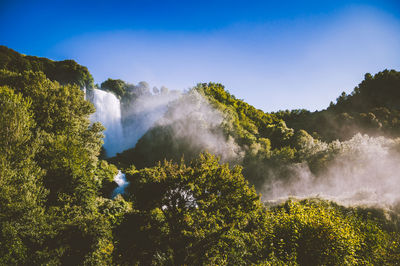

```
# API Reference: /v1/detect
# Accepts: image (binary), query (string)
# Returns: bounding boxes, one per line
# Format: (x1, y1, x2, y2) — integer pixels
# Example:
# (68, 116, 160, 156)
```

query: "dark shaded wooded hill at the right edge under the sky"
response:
(276, 70, 400, 141)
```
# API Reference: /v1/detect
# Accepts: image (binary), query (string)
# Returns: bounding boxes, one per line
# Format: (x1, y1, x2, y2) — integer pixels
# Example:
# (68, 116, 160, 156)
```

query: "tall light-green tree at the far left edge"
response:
(0, 86, 52, 265)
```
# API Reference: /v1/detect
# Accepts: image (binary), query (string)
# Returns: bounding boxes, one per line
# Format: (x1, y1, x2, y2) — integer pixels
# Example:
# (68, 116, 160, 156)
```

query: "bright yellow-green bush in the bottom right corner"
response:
(266, 199, 399, 265)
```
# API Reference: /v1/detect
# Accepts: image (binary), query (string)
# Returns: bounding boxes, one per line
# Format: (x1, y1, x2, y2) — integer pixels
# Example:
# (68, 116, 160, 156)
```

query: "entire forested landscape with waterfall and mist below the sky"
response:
(0, 46, 400, 265)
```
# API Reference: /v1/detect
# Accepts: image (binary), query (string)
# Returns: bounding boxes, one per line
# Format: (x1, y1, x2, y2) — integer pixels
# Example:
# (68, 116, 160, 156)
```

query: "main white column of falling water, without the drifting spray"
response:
(91, 89, 124, 157)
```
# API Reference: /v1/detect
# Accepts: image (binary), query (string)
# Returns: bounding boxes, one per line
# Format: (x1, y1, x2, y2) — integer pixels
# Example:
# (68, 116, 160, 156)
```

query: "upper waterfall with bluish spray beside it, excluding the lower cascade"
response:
(88, 85, 181, 157)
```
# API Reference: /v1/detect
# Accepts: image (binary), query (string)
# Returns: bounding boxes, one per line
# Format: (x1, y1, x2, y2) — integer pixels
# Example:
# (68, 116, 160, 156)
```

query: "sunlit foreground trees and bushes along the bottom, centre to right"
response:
(112, 154, 400, 265)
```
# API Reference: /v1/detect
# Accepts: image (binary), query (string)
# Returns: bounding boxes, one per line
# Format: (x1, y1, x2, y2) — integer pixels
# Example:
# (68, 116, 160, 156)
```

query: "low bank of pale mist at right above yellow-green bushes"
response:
(263, 134, 400, 211)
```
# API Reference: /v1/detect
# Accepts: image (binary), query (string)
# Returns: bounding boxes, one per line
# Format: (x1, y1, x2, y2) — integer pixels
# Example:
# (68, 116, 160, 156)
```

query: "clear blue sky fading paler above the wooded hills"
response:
(0, 0, 400, 111)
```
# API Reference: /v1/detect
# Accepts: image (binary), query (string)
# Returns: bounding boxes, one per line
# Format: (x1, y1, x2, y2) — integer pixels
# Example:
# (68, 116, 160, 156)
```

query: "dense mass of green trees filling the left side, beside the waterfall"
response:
(0, 67, 119, 265)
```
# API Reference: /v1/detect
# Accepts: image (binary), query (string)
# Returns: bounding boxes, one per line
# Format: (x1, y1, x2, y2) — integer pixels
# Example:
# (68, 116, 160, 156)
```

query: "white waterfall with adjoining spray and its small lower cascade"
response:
(89, 89, 179, 198)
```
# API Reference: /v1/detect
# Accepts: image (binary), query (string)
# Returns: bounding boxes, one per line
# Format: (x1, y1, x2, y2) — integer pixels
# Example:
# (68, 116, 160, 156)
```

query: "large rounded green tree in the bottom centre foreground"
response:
(116, 154, 266, 265)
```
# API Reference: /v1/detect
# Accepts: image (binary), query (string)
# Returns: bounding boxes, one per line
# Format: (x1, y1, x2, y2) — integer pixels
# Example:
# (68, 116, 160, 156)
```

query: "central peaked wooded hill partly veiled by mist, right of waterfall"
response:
(110, 83, 299, 186)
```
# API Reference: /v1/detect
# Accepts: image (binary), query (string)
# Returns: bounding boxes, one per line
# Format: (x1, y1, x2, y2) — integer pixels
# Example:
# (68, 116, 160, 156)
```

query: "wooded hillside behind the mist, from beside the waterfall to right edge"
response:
(110, 74, 400, 191)
